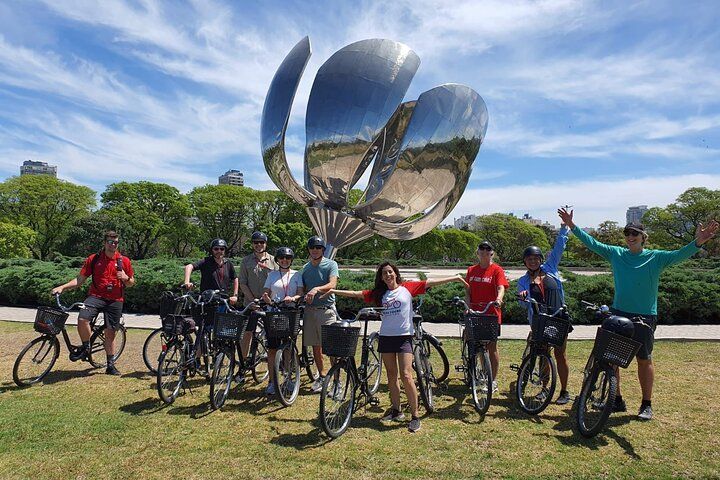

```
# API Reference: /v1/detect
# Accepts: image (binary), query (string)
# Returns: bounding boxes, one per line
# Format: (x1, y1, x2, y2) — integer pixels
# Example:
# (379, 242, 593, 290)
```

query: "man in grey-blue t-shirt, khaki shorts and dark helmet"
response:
(301, 236, 338, 392)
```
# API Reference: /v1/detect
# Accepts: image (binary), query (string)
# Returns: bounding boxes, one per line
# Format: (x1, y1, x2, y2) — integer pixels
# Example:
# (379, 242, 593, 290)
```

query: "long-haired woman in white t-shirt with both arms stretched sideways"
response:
(328, 262, 467, 432)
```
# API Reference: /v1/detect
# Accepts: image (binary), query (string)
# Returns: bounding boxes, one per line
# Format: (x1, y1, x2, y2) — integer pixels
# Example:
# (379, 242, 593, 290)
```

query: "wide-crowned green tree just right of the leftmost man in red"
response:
(101, 181, 190, 259)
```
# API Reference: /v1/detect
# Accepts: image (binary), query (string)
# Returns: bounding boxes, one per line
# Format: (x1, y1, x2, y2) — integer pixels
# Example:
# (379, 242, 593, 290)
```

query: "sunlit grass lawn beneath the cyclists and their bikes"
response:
(0, 322, 720, 480)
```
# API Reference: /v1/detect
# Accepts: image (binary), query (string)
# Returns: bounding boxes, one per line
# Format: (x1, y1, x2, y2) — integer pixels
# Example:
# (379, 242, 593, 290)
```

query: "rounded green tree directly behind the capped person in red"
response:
(475, 213, 550, 261)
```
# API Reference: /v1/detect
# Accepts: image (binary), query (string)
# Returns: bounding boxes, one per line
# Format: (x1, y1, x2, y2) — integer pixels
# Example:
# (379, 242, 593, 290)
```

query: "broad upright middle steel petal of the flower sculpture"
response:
(305, 39, 420, 209)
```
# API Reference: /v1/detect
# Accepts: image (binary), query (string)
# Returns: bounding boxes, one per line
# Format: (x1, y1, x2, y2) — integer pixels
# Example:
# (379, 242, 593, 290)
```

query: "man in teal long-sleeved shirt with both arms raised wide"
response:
(558, 208, 720, 420)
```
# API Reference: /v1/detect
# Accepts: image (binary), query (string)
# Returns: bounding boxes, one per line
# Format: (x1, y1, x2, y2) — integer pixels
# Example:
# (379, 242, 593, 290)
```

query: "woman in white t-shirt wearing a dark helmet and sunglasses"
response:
(262, 247, 303, 395)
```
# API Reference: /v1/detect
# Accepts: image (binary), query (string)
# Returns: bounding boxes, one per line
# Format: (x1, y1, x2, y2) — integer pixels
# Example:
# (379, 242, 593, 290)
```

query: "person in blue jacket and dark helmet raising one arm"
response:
(518, 225, 572, 405)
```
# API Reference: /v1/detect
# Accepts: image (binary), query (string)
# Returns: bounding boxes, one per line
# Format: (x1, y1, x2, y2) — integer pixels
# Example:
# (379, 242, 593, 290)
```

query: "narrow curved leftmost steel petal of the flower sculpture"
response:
(260, 37, 315, 205)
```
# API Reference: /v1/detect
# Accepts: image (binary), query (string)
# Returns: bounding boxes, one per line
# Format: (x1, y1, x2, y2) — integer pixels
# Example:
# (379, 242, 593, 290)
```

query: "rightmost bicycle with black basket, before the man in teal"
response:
(575, 300, 652, 438)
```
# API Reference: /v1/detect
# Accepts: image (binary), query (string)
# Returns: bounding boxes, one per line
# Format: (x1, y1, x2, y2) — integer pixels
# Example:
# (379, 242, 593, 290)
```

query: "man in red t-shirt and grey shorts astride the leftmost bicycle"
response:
(52, 230, 135, 375)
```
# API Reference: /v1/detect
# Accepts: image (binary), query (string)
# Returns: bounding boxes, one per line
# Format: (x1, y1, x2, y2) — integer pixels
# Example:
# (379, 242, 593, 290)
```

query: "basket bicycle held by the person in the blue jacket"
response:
(510, 295, 572, 415)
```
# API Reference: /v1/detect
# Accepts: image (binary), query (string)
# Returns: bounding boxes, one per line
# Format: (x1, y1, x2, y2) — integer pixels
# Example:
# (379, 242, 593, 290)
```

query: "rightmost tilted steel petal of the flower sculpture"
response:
(355, 84, 488, 224)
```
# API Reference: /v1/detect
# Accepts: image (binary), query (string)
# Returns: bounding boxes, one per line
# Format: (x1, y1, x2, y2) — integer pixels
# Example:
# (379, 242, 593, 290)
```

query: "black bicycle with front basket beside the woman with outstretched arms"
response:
(319, 307, 384, 438)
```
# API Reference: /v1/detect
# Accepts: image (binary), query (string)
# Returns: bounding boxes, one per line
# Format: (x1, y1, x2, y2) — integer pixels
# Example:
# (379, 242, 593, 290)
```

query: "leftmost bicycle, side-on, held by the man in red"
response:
(13, 293, 126, 387)
